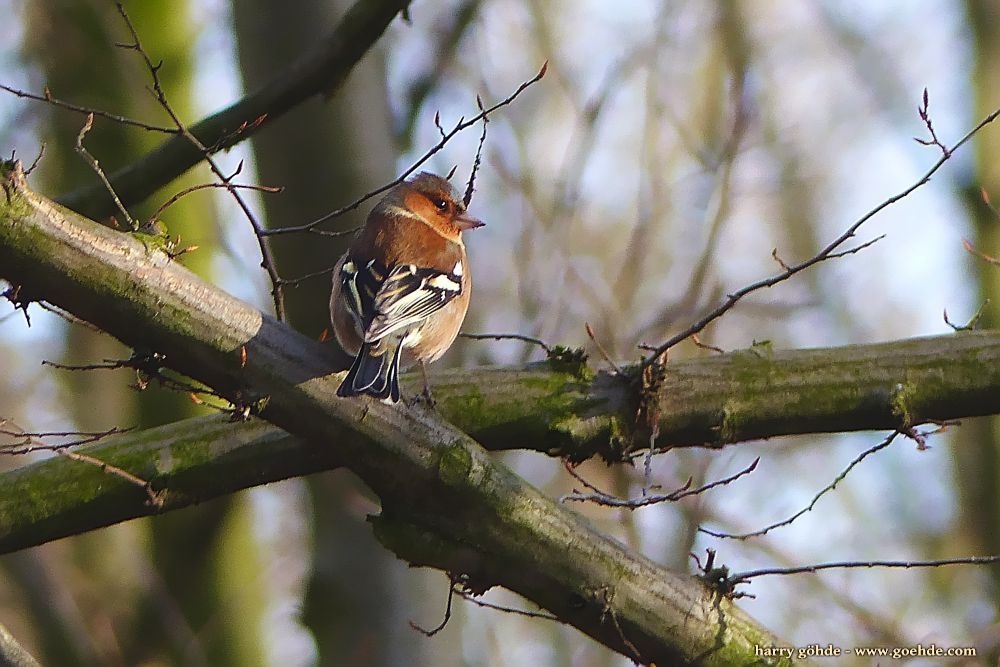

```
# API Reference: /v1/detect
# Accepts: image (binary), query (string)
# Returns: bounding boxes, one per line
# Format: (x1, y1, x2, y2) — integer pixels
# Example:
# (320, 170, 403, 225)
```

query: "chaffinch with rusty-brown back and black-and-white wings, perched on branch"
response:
(330, 172, 484, 403)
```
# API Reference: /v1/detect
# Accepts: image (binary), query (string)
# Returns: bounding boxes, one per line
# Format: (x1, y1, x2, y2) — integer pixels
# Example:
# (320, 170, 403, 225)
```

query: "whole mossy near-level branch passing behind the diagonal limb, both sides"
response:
(0, 331, 1000, 553)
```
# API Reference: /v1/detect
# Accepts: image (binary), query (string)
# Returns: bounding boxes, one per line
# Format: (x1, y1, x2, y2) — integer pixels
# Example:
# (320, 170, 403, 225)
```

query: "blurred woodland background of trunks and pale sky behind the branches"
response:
(0, 0, 1000, 665)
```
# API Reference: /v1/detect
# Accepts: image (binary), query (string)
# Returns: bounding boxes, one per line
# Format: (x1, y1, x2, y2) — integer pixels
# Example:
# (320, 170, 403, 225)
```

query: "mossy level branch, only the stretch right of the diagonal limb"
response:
(430, 331, 1000, 460)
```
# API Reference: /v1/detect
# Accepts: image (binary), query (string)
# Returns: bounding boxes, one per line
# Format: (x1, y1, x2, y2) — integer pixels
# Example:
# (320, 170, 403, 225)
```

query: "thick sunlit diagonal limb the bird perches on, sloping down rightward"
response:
(0, 163, 777, 665)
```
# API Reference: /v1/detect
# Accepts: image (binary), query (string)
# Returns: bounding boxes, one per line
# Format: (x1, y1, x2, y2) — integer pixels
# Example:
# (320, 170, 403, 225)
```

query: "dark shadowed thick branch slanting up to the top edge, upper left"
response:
(53, 0, 410, 219)
